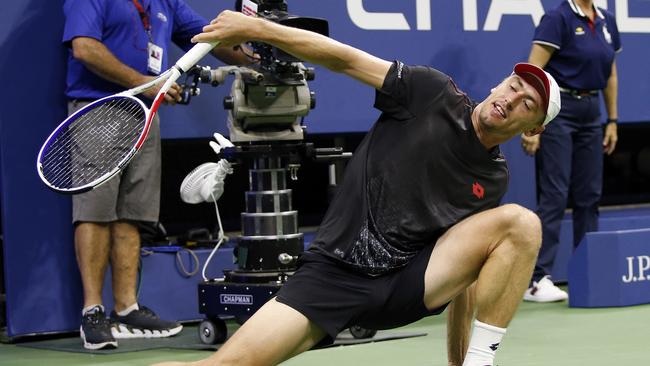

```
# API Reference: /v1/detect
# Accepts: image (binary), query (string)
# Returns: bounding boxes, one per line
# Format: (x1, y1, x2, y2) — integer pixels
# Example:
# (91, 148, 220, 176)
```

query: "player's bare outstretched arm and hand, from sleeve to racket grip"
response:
(192, 10, 391, 89)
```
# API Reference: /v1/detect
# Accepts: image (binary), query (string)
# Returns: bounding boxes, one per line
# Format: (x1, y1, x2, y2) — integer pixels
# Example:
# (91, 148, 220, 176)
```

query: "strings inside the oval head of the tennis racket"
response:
(42, 97, 146, 189)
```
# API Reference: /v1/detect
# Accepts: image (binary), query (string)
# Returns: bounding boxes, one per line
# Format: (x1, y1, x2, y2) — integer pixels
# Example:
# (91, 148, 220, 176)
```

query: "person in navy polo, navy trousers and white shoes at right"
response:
(522, 0, 621, 302)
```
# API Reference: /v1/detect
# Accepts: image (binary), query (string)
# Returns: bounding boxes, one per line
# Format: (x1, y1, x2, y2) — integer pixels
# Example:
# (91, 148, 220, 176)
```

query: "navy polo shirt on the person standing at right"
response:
(533, 0, 621, 90)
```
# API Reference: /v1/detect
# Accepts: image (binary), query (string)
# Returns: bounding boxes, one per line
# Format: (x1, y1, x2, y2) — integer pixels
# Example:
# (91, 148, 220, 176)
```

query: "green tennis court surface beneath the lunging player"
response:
(0, 303, 650, 366)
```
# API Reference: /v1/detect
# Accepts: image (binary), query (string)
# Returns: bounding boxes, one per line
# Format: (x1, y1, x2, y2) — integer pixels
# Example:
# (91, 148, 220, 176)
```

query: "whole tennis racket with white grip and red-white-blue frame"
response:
(36, 42, 218, 194)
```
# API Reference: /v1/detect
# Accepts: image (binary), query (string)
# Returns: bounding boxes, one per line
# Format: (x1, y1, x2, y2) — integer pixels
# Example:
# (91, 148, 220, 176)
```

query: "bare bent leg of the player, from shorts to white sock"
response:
(424, 205, 541, 327)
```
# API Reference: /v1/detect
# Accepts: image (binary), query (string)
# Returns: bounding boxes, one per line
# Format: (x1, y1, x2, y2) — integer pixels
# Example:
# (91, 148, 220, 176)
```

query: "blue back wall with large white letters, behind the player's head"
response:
(162, 0, 650, 137)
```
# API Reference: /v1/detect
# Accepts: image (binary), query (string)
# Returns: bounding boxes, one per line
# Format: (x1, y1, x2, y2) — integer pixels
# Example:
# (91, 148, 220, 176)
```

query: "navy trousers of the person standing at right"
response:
(533, 93, 603, 281)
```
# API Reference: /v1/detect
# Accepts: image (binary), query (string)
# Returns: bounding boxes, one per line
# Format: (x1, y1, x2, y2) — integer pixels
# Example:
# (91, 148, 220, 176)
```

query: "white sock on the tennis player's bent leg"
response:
(463, 320, 506, 366)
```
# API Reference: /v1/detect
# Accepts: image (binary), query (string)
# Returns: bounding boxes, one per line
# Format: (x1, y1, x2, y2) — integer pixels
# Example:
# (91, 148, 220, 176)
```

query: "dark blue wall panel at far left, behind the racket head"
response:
(0, 0, 81, 335)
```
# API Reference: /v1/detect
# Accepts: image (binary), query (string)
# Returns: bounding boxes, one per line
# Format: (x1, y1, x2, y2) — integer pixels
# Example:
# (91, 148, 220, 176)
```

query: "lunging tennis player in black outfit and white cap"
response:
(154, 6, 560, 366)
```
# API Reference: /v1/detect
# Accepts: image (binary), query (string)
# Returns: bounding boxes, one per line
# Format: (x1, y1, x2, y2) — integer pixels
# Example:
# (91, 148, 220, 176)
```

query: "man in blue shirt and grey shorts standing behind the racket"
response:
(63, 0, 246, 349)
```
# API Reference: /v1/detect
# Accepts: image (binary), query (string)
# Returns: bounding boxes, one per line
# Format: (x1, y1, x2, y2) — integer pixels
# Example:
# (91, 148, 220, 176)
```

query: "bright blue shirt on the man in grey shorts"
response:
(63, 0, 208, 99)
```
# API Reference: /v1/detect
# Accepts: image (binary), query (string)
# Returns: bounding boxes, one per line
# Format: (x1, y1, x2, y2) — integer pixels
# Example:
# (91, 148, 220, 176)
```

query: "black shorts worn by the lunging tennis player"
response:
(276, 245, 447, 342)
